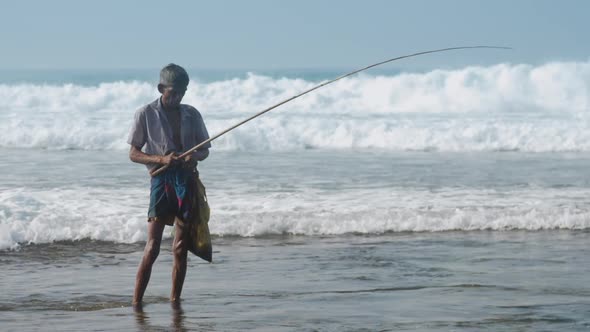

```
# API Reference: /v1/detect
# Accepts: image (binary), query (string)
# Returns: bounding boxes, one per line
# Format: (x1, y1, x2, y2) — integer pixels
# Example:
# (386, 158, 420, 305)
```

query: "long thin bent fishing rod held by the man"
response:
(150, 45, 511, 176)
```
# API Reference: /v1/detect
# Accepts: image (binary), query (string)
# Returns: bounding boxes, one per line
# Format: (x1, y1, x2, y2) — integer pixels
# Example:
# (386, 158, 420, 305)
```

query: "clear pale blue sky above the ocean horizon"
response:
(0, 0, 590, 70)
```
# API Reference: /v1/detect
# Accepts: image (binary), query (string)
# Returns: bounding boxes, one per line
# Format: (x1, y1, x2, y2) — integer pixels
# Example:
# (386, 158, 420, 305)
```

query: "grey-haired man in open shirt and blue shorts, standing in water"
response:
(127, 64, 211, 306)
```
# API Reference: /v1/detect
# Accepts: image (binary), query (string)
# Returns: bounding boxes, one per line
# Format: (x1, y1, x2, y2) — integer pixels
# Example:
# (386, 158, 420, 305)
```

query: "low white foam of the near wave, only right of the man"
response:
(210, 189, 590, 236)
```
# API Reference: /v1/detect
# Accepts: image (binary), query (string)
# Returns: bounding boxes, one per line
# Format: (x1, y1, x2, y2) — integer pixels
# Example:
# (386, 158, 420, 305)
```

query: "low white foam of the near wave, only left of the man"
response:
(0, 188, 147, 249)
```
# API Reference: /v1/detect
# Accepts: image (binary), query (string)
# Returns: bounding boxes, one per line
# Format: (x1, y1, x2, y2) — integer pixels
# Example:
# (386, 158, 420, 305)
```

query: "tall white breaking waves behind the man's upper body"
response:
(0, 62, 590, 152)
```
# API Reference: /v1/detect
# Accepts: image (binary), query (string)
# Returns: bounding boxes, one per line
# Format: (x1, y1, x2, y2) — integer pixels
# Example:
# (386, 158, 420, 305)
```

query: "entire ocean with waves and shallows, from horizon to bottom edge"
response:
(0, 62, 590, 331)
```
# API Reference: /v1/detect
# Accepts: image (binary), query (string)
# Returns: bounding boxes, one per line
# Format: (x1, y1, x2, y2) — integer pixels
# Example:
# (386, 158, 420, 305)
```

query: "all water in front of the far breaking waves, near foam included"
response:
(0, 149, 590, 331)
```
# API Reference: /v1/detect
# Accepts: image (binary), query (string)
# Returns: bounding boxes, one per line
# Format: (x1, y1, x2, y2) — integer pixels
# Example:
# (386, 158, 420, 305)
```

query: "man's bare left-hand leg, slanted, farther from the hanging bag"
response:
(133, 221, 166, 306)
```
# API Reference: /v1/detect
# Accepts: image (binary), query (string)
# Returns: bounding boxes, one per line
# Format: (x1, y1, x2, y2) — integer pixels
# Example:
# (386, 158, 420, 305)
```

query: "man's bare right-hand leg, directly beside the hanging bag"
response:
(170, 220, 189, 302)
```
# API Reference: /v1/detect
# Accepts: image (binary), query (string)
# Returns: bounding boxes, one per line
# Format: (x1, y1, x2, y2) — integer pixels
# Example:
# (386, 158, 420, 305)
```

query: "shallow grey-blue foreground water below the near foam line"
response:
(0, 231, 590, 331)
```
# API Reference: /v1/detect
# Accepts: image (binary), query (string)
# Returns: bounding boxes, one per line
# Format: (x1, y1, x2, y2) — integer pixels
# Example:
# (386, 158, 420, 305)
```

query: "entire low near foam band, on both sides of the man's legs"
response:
(0, 188, 590, 249)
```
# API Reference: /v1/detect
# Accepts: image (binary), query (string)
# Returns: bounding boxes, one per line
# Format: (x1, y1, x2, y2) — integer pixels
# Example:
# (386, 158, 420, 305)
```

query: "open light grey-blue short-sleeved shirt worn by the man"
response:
(127, 98, 211, 170)
